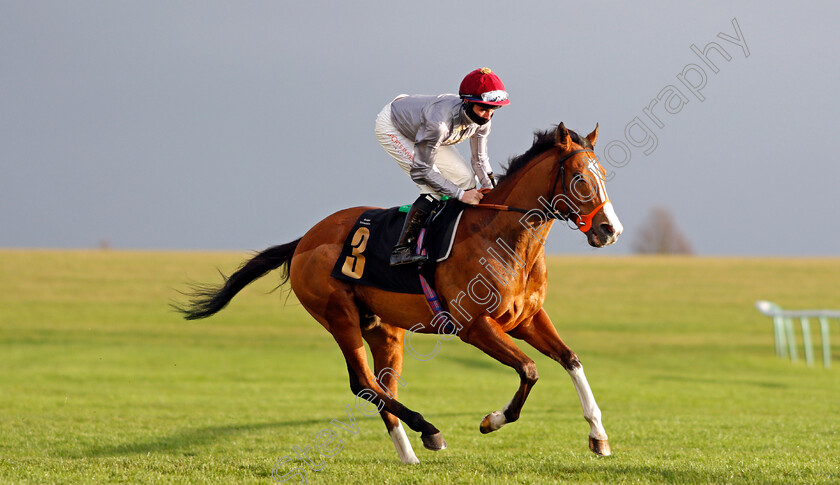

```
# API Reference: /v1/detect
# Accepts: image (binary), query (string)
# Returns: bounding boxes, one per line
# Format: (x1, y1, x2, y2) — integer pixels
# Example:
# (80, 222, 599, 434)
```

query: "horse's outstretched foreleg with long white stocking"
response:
(510, 309, 612, 456)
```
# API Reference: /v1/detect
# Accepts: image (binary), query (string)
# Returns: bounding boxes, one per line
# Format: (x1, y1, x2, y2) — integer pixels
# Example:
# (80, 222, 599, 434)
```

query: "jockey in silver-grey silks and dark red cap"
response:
(376, 67, 510, 266)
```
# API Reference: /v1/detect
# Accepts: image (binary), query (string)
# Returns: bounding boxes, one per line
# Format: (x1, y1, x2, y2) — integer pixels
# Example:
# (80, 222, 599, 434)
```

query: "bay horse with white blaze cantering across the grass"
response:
(176, 123, 622, 463)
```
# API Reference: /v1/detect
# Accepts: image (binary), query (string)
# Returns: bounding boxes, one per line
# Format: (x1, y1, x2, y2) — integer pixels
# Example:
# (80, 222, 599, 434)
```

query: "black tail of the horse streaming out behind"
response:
(172, 239, 300, 320)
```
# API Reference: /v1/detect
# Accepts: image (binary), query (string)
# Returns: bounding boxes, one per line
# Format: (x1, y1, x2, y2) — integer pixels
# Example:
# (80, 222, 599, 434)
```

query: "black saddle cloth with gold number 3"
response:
(332, 199, 466, 294)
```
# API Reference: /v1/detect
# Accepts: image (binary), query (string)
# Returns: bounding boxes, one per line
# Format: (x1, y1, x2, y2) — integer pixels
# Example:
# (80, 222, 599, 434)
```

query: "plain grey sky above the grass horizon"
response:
(0, 0, 840, 256)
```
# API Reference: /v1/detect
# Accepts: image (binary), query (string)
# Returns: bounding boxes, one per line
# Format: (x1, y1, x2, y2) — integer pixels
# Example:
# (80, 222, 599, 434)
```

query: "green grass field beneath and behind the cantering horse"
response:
(0, 250, 840, 484)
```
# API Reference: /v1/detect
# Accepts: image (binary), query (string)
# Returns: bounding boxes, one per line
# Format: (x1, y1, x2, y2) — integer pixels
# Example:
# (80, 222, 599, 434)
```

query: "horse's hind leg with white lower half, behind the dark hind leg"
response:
(362, 318, 420, 464)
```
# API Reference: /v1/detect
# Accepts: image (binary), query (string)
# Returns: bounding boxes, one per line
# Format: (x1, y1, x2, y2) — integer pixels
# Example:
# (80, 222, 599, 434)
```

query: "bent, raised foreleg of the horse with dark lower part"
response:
(459, 316, 539, 433)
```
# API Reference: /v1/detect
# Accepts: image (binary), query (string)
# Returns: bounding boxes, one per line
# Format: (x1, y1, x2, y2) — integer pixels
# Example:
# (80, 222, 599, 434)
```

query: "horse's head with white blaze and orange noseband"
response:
(553, 123, 624, 248)
